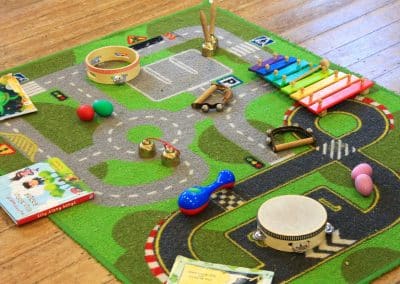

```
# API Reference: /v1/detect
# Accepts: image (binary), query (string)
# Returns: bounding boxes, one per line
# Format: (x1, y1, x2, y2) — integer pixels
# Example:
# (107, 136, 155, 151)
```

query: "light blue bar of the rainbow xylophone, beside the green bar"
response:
(264, 60, 310, 88)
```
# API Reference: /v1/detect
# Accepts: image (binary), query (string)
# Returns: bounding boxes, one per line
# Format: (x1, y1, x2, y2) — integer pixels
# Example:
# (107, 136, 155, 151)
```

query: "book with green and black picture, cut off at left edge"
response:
(0, 74, 37, 120)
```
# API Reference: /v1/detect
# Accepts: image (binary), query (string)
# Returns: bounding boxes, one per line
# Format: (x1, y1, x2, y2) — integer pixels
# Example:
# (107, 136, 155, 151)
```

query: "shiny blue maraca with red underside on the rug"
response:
(178, 170, 235, 215)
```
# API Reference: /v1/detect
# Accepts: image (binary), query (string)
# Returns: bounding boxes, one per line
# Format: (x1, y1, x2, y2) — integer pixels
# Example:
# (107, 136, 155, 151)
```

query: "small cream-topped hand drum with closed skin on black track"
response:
(254, 195, 328, 253)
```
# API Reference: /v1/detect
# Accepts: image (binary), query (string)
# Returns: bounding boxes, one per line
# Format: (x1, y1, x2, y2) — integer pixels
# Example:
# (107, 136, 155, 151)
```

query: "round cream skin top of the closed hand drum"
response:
(257, 195, 327, 236)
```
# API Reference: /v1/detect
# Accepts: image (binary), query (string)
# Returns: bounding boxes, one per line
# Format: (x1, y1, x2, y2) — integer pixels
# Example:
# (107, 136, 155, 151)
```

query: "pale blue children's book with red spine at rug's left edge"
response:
(0, 158, 94, 225)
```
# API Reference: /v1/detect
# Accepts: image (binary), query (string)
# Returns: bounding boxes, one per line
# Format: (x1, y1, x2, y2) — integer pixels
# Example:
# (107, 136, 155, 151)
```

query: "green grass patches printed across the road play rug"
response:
(0, 3, 400, 283)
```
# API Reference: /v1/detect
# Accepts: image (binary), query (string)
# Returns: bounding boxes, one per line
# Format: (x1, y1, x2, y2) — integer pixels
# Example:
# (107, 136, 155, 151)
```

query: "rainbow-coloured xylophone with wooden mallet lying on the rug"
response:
(249, 54, 374, 116)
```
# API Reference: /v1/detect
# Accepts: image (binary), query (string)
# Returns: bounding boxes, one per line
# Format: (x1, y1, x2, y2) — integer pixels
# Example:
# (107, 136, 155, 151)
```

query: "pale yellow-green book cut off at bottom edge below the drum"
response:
(167, 255, 274, 284)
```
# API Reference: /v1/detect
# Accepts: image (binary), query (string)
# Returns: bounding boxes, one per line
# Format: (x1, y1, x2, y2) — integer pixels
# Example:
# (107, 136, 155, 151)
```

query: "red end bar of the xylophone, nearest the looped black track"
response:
(308, 79, 374, 115)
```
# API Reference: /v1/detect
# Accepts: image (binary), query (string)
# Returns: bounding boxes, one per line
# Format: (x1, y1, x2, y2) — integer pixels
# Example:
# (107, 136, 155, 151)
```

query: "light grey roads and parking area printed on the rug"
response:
(1, 27, 296, 206)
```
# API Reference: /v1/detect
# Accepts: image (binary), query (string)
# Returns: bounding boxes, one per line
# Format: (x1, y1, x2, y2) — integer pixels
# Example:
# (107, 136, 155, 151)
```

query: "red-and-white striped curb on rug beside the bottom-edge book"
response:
(144, 220, 168, 283)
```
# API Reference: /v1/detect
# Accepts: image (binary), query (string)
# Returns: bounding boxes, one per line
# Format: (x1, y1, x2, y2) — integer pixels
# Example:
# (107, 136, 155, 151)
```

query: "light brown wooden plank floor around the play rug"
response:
(0, 0, 400, 283)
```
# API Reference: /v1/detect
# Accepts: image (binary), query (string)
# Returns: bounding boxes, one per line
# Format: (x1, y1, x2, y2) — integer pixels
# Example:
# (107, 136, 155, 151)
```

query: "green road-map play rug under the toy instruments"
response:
(0, 3, 400, 283)
